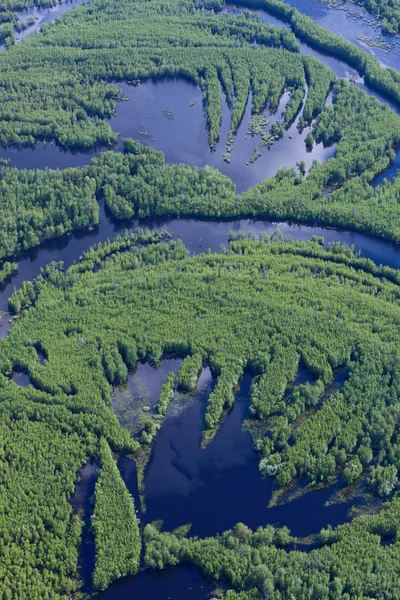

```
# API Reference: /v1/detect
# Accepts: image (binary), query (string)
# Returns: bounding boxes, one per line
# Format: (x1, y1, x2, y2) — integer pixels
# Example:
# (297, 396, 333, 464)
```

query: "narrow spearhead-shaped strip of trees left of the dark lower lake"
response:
(92, 438, 141, 591)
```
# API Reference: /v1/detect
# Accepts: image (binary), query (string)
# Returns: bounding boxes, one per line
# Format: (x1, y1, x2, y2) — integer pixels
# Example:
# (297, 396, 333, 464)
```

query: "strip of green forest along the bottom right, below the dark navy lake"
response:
(145, 499, 400, 600)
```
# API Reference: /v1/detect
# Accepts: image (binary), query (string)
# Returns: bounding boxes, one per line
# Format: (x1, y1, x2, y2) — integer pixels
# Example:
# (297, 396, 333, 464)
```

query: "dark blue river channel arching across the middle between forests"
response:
(0, 202, 400, 318)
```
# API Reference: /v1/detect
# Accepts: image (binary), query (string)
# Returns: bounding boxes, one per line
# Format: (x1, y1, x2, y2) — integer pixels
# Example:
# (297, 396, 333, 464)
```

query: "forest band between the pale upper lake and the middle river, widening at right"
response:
(0, 71, 400, 259)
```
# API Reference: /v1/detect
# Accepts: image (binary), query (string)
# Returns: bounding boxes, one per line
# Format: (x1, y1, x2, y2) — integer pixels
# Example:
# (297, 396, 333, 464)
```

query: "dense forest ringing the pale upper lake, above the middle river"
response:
(0, 0, 400, 259)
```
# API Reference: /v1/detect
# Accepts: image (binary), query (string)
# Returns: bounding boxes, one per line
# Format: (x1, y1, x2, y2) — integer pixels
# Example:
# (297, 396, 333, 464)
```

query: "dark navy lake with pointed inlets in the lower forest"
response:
(119, 370, 362, 537)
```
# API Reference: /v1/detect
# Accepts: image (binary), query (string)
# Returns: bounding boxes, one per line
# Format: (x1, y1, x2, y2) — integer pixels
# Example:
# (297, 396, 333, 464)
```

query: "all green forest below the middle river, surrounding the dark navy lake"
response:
(0, 231, 400, 600)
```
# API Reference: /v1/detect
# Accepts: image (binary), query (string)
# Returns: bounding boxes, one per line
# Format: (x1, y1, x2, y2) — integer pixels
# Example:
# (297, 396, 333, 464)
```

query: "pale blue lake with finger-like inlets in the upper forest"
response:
(111, 79, 336, 193)
